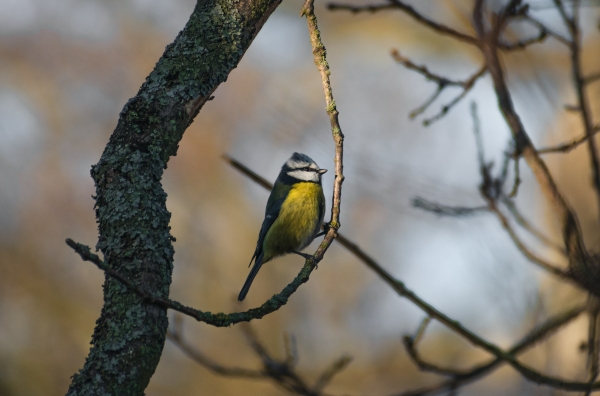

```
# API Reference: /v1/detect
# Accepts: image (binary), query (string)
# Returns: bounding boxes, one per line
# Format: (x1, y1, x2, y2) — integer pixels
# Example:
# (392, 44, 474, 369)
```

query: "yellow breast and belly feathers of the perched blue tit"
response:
(263, 182, 325, 262)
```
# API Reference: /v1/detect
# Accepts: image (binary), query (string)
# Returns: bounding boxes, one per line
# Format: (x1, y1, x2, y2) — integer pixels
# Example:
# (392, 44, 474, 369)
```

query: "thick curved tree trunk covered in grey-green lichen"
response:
(67, 0, 281, 396)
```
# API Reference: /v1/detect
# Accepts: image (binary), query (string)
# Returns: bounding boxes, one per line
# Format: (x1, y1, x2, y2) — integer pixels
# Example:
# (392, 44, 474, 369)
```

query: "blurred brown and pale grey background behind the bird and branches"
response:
(0, 0, 600, 396)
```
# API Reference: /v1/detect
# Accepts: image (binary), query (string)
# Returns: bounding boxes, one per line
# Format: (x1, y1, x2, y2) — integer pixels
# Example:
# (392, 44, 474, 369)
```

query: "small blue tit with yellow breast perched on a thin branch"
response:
(238, 153, 327, 301)
